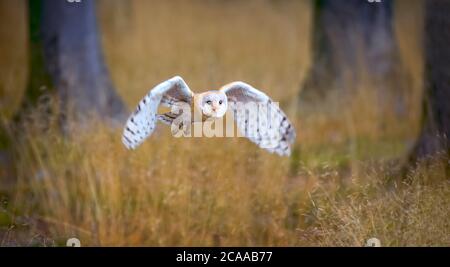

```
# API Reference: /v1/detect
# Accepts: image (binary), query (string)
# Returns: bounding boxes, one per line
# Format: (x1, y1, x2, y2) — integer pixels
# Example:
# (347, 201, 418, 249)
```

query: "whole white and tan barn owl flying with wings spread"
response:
(122, 76, 295, 156)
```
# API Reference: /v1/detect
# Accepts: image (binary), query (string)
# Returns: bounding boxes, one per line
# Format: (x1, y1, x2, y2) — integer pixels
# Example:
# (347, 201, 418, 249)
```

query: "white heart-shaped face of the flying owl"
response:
(201, 91, 228, 118)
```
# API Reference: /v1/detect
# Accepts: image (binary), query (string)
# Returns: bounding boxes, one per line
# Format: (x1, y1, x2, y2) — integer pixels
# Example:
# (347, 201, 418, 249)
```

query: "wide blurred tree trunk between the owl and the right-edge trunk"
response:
(301, 0, 399, 100)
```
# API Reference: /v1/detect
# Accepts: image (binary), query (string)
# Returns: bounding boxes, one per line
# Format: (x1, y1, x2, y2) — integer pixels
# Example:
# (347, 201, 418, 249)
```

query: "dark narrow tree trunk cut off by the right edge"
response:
(411, 0, 450, 165)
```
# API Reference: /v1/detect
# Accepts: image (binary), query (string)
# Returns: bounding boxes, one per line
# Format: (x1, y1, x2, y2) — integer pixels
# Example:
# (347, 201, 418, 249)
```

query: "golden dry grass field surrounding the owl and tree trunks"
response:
(0, 0, 450, 246)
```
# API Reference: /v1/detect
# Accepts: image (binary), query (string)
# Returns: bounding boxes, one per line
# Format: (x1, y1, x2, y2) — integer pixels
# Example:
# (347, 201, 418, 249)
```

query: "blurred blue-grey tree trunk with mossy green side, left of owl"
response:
(24, 0, 125, 123)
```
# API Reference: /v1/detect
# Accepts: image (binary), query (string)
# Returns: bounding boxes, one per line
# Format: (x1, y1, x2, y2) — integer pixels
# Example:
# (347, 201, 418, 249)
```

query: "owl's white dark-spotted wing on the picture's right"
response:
(220, 82, 295, 156)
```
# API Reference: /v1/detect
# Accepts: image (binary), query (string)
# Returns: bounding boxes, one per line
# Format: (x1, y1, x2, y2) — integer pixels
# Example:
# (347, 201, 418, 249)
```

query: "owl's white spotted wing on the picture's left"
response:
(122, 76, 194, 149)
